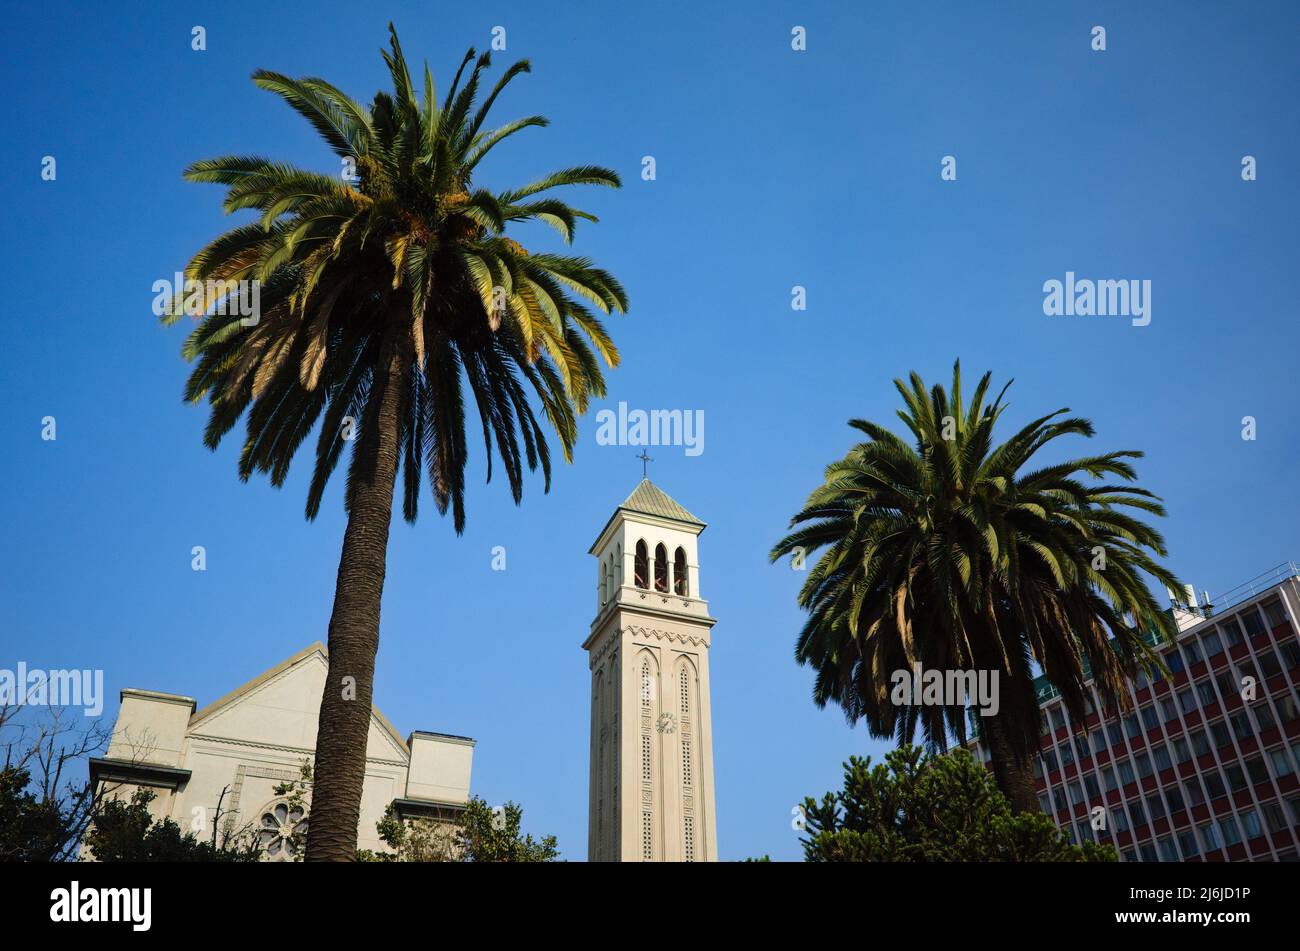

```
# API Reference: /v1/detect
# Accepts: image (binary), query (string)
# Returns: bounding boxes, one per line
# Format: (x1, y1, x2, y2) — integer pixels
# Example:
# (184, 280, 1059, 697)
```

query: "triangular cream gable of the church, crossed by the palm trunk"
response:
(189, 642, 410, 764)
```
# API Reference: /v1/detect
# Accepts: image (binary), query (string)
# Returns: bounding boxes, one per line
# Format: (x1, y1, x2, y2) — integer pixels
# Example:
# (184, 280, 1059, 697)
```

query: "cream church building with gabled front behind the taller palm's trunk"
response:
(90, 642, 475, 861)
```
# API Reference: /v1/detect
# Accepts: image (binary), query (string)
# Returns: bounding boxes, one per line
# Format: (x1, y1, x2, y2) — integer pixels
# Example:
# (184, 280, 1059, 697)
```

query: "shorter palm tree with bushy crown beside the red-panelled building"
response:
(771, 361, 1178, 811)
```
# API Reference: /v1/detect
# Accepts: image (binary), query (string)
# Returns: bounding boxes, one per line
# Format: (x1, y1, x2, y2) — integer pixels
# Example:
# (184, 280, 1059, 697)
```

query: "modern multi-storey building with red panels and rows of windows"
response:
(971, 564, 1300, 861)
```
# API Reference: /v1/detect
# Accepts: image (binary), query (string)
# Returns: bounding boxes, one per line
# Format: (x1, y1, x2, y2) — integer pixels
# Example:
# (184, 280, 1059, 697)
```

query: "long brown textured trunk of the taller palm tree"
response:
(307, 335, 402, 861)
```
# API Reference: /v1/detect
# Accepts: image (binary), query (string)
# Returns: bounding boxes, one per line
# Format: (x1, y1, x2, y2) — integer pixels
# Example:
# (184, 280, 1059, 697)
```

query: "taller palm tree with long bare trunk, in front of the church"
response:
(164, 23, 628, 860)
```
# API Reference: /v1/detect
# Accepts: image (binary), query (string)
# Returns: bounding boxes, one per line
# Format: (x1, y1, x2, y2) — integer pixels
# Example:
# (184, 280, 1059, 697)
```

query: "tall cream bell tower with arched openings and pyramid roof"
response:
(582, 478, 718, 861)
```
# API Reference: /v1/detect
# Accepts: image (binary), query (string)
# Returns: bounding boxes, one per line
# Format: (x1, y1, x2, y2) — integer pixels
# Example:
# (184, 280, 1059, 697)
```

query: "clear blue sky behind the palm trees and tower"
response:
(0, 0, 1300, 859)
